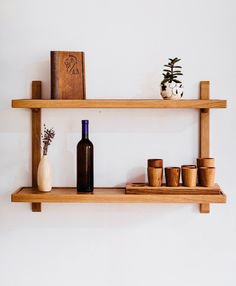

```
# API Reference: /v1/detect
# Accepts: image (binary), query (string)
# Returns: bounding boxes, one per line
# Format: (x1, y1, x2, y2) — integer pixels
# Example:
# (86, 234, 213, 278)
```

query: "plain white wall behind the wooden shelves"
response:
(0, 0, 236, 286)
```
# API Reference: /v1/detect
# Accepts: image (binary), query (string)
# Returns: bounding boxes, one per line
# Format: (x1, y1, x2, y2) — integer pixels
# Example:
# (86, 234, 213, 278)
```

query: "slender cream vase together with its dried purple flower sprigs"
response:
(37, 124, 55, 192)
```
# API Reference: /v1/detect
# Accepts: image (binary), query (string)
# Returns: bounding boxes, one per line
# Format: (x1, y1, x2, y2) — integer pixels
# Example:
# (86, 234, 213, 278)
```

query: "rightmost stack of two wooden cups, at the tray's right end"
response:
(197, 158, 215, 187)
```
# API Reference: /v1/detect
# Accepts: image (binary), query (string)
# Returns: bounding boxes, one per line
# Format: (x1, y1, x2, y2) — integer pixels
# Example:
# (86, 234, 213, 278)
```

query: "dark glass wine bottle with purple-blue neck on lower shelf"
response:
(77, 120, 93, 193)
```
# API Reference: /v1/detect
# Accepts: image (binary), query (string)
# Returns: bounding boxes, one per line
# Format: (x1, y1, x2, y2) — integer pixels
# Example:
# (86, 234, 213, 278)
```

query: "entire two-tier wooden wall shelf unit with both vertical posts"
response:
(11, 81, 227, 213)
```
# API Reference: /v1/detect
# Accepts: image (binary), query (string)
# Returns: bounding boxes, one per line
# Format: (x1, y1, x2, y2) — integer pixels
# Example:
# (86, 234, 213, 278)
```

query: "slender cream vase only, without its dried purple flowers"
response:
(37, 155, 52, 192)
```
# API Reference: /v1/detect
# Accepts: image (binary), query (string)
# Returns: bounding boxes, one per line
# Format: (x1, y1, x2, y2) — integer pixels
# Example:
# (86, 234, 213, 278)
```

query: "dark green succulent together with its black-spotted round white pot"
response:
(161, 58, 184, 99)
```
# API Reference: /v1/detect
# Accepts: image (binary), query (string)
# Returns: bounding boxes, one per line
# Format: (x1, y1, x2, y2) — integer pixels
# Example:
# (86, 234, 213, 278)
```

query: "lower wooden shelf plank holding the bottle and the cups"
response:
(11, 185, 226, 212)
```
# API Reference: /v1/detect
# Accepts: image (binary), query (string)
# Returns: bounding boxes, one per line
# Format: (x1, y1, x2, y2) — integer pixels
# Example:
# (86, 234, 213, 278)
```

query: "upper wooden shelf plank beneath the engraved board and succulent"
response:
(12, 99, 227, 108)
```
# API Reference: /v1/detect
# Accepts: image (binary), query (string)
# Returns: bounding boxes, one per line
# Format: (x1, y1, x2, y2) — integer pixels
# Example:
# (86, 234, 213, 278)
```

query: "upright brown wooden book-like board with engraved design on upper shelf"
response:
(51, 51, 85, 99)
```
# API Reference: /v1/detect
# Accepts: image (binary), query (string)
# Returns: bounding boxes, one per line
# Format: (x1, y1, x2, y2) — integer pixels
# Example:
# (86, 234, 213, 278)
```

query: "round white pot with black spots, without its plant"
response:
(161, 81, 184, 99)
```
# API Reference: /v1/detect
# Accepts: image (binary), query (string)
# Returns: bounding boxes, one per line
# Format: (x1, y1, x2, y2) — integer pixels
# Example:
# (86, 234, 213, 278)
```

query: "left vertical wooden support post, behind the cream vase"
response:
(32, 81, 41, 212)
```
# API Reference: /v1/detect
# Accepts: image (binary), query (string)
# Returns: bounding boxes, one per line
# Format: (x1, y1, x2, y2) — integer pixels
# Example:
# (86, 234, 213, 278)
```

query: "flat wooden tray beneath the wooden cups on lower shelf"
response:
(125, 183, 221, 195)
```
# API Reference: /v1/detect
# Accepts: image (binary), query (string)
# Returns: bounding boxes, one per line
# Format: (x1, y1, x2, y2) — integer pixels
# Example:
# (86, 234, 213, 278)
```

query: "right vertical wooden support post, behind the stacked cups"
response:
(199, 81, 210, 213)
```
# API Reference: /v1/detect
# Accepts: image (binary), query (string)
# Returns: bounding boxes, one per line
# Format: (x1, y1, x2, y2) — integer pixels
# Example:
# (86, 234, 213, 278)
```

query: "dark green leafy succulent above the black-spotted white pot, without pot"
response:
(161, 58, 183, 85)
